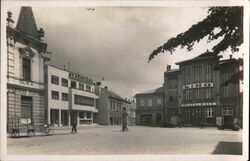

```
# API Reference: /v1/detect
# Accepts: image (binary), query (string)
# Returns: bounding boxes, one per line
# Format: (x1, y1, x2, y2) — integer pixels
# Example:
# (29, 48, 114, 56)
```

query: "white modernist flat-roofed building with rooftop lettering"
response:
(45, 65, 98, 126)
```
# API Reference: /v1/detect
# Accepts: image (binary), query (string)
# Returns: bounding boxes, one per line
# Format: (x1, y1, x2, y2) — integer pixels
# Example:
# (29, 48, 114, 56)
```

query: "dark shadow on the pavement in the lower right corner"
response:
(212, 141, 242, 155)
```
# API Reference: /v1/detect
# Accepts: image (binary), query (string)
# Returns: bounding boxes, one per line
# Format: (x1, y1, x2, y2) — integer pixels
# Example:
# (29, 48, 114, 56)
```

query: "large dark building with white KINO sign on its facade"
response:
(164, 52, 241, 126)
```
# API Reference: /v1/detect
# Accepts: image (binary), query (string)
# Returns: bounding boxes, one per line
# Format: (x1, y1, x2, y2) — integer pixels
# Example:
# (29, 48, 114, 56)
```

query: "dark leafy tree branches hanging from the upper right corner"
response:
(148, 6, 243, 62)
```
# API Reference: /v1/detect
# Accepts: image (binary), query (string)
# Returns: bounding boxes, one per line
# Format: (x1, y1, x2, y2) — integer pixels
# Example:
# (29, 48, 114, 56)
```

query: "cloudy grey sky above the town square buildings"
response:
(9, 7, 242, 98)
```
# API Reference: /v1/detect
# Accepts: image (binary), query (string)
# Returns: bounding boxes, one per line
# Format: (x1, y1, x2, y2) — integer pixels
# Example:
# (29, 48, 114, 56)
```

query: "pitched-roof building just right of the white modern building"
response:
(96, 85, 130, 125)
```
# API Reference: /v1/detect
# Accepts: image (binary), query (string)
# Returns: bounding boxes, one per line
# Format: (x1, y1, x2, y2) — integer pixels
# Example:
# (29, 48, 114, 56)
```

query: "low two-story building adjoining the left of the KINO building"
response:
(135, 87, 164, 126)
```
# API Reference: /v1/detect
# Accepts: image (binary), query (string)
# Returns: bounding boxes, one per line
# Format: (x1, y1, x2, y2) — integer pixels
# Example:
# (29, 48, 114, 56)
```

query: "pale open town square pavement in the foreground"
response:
(7, 125, 242, 155)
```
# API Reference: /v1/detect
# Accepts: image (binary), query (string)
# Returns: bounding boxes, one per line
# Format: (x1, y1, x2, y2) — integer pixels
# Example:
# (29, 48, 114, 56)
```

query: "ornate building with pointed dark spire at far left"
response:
(7, 7, 48, 132)
